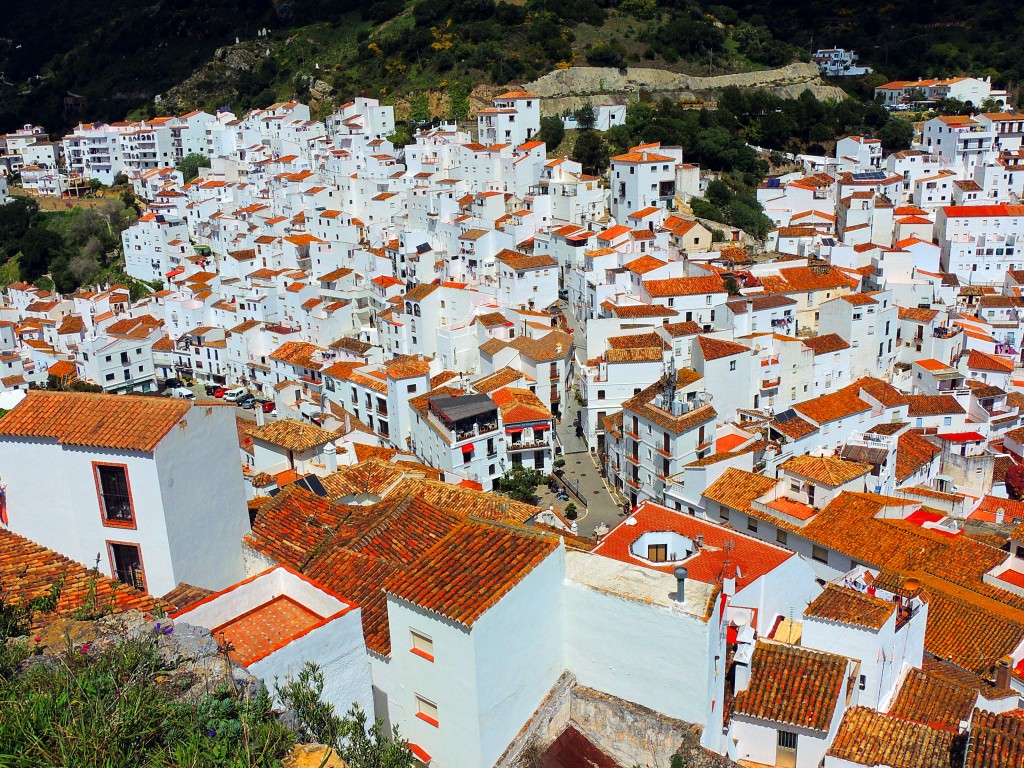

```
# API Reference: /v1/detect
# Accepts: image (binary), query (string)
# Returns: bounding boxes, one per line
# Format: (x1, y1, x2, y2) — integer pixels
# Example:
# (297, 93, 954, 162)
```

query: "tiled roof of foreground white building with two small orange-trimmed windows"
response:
(385, 520, 558, 627)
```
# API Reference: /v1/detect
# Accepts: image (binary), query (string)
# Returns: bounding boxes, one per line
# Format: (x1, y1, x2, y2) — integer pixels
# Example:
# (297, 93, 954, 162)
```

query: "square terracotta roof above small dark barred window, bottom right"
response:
(733, 641, 849, 731)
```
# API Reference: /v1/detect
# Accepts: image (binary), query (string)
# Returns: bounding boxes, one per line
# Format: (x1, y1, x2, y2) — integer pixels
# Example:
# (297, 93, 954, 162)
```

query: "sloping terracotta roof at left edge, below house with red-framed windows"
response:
(0, 528, 160, 615)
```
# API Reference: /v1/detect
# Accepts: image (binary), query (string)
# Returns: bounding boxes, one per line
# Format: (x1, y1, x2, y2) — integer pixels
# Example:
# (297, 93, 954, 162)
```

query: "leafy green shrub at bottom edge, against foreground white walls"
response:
(278, 662, 413, 768)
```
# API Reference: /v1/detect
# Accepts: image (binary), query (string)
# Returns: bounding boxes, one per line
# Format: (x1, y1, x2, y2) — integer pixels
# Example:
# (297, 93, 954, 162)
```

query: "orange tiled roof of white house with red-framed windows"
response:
(0, 390, 191, 452)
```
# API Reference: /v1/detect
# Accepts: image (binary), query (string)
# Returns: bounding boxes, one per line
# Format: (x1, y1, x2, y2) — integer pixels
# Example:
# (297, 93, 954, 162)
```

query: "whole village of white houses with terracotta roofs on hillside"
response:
(0, 93, 1024, 768)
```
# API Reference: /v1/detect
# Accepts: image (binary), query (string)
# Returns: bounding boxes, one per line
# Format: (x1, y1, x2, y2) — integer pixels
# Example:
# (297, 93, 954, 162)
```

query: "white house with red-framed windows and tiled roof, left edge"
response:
(0, 391, 249, 595)
